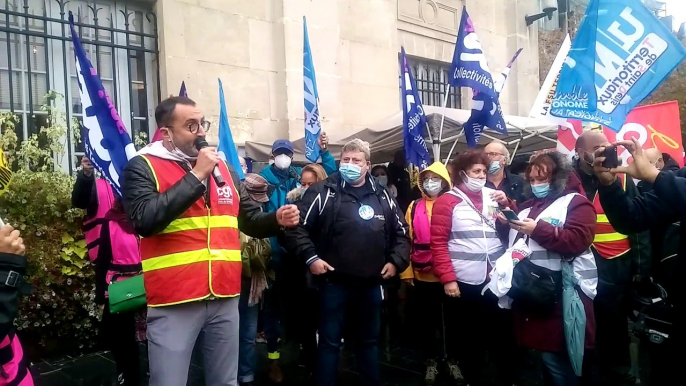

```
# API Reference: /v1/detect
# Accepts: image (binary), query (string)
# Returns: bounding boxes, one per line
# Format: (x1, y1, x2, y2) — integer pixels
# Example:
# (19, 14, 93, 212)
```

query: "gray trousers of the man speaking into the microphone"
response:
(148, 297, 239, 386)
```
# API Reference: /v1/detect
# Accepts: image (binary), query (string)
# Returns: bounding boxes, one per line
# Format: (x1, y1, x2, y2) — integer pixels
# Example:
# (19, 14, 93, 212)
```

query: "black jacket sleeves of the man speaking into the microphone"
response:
(121, 157, 280, 238)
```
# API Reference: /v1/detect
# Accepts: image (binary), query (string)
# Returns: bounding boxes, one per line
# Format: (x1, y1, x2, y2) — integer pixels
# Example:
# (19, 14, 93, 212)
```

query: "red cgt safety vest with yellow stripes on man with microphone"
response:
(141, 155, 242, 307)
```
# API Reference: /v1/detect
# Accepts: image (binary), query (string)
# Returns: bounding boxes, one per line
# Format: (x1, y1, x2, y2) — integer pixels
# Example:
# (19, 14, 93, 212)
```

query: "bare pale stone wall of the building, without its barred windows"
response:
(156, 0, 540, 143)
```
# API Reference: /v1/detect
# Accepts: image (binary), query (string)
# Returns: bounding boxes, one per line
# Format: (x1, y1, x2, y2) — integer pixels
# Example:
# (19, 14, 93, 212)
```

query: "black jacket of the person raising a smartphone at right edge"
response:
(598, 168, 686, 362)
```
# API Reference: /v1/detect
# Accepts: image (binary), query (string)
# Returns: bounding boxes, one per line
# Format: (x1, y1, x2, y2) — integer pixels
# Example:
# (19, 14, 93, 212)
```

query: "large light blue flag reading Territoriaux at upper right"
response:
(550, 0, 686, 132)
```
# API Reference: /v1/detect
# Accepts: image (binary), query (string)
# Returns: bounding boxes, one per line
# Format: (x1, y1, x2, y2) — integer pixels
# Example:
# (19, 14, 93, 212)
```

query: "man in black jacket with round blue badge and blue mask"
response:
(287, 139, 410, 386)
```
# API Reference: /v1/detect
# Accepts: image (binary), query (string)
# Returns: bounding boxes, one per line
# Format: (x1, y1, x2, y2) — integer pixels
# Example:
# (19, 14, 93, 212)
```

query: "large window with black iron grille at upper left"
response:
(0, 0, 160, 171)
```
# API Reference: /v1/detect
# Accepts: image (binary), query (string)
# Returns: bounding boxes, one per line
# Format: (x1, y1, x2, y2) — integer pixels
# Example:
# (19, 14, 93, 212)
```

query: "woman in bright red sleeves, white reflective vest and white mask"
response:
(431, 150, 514, 385)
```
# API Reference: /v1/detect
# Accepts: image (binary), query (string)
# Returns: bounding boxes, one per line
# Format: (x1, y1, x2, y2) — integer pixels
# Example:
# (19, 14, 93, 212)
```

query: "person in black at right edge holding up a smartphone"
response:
(594, 139, 686, 385)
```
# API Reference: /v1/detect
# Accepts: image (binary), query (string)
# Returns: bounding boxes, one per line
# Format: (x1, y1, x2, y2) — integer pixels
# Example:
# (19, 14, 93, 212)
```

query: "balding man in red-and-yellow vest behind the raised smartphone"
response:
(574, 131, 651, 385)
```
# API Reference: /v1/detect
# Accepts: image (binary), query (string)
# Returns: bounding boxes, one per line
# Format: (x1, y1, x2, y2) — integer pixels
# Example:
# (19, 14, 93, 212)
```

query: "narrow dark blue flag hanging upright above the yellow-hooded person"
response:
(400, 47, 431, 170)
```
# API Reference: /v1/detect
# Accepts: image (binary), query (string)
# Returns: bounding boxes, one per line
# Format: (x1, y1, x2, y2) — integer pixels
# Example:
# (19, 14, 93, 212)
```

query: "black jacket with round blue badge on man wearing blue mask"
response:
(286, 173, 410, 282)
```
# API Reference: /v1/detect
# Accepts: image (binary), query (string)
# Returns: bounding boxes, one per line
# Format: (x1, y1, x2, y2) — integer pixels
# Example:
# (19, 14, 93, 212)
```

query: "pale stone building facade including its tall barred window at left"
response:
(0, 0, 550, 170)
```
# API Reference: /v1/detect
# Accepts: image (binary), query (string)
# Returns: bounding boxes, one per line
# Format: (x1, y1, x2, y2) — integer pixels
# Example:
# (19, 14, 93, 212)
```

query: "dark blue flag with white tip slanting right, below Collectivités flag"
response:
(463, 48, 522, 149)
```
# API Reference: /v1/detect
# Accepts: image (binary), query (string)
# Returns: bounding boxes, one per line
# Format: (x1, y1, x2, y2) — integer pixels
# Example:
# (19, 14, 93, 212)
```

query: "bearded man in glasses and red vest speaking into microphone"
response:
(122, 97, 300, 386)
